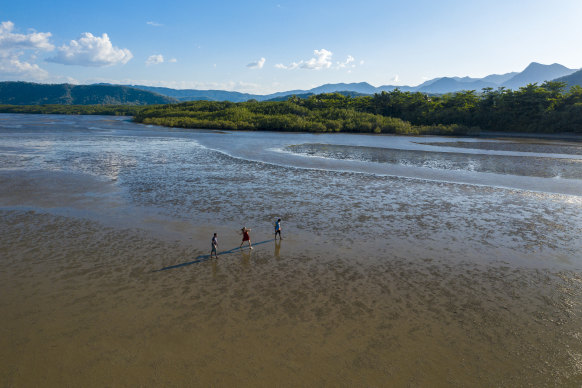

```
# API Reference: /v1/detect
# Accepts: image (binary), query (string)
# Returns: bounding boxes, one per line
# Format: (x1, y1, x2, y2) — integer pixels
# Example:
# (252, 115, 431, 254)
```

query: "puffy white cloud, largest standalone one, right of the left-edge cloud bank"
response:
(47, 32, 133, 67)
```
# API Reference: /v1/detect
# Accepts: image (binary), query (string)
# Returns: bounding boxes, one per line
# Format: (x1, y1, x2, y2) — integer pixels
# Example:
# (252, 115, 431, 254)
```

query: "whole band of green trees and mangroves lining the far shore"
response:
(0, 81, 582, 135)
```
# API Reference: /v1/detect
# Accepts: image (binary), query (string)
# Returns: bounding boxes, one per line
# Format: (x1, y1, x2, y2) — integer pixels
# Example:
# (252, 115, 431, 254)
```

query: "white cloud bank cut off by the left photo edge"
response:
(0, 21, 54, 80)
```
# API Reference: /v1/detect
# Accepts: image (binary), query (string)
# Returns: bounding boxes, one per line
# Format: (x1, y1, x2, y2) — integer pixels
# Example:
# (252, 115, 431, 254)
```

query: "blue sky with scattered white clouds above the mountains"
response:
(0, 0, 582, 94)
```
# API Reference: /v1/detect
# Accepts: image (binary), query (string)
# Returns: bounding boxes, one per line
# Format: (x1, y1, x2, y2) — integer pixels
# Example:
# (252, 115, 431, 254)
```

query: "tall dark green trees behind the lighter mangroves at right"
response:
(368, 82, 582, 133)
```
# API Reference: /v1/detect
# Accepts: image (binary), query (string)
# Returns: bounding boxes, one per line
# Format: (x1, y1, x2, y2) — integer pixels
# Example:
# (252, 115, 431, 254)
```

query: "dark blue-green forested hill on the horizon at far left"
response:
(0, 82, 176, 105)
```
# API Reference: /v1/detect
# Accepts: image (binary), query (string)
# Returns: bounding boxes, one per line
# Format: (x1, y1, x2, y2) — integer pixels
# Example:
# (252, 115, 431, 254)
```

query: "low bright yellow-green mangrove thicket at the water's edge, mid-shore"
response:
(134, 93, 478, 135)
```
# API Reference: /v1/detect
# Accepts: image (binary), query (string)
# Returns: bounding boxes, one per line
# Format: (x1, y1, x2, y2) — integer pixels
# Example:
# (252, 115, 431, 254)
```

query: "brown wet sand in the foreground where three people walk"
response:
(0, 210, 582, 387)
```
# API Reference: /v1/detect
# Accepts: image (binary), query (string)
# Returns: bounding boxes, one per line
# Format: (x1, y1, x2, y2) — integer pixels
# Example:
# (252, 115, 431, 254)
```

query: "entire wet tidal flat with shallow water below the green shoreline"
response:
(0, 115, 582, 386)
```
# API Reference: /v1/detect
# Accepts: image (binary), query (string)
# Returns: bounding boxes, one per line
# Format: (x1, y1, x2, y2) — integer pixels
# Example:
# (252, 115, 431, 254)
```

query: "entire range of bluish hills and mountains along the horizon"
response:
(0, 62, 582, 105)
